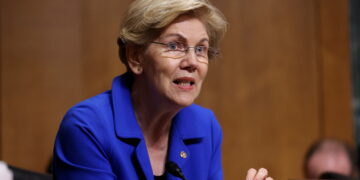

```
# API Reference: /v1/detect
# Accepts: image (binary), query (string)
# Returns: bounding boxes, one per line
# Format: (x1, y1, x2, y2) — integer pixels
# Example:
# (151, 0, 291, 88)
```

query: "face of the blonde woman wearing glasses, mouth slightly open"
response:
(141, 16, 209, 107)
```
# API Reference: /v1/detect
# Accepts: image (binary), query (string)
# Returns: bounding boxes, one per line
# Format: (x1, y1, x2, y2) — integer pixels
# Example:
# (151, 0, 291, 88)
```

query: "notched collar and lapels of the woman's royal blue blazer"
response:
(112, 73, 205, 140)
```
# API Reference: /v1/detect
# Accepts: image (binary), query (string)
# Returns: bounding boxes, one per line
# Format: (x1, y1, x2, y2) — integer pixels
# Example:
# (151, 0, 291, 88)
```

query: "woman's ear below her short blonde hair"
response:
(126, 45, 143, 75)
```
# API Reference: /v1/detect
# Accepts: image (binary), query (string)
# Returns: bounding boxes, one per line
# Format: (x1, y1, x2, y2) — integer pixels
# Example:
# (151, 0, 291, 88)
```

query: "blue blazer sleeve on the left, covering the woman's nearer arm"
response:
(54, 107, 116, 180)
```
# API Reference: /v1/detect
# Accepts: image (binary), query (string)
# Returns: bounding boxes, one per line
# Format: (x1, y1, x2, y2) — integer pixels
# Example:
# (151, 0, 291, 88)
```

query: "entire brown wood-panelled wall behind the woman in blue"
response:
(0, 0, 360, 180)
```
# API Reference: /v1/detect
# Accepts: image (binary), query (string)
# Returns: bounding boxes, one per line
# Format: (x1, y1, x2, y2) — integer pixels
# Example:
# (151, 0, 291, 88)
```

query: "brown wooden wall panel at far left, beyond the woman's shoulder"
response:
(1, 0, 82, 171)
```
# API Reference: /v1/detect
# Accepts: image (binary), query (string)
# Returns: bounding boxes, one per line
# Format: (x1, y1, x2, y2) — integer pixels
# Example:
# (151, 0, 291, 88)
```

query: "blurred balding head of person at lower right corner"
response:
(303, 139, 357, 179)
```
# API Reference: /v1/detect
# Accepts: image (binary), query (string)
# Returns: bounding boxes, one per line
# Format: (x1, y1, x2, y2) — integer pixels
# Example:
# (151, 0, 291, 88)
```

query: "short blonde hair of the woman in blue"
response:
(118, 0, 227, 66)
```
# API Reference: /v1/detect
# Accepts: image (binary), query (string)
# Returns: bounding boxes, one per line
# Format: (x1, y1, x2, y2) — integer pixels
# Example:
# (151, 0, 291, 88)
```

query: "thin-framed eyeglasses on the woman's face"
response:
(151, 42, 219, 63)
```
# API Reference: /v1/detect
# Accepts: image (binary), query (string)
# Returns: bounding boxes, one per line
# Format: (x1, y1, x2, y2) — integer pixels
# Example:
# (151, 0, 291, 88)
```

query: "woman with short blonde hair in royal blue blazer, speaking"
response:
(54, 0, 267, 180)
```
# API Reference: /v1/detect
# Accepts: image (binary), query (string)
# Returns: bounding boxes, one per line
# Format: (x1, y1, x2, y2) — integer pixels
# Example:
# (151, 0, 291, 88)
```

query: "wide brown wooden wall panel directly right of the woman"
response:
(199, 0, 321, 179)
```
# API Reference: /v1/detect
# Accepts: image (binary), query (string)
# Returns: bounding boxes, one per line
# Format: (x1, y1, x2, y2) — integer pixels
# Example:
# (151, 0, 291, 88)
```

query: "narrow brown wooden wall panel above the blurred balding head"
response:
(318, 0, 354, 142)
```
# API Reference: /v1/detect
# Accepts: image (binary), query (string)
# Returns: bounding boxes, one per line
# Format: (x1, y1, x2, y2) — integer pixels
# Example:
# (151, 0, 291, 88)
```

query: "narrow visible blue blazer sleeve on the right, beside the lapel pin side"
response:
(209, 114, 224, 180)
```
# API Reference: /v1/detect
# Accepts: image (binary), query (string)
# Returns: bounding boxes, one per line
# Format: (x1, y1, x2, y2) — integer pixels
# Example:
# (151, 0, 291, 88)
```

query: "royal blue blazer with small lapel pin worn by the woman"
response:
(54, 73, 223, 180)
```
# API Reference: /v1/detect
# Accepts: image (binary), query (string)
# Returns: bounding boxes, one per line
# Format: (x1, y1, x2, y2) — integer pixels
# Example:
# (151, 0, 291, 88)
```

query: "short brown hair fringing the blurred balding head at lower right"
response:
(303, 138, 357, 177)
